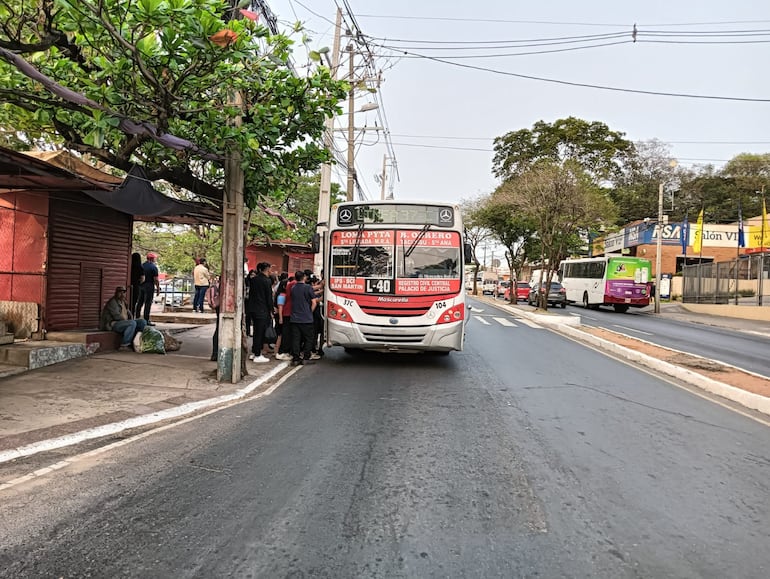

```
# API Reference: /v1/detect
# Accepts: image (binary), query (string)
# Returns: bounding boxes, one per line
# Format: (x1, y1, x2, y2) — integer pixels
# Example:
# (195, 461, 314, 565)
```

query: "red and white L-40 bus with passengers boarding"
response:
(324, 200, 470, 354)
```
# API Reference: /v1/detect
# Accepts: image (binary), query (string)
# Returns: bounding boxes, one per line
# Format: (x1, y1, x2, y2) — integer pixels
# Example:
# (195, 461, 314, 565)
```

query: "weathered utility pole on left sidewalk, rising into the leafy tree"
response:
(217, 91, 244, 384)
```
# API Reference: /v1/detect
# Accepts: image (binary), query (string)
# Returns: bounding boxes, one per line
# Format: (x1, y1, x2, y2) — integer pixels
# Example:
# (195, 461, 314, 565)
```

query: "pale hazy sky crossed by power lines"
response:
(260, 0, 770, 207)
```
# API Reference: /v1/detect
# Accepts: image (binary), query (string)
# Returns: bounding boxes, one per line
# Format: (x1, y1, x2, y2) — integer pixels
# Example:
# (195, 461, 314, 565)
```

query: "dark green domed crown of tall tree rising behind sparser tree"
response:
(492, 117, 634, 183)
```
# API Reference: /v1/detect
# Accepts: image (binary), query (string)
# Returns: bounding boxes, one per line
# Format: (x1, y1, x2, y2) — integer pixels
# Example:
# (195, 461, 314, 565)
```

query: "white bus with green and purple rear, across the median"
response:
(558, 255, 652, 313)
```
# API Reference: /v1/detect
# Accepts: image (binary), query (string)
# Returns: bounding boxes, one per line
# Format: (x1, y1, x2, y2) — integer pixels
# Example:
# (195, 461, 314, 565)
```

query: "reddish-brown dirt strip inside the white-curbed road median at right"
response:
(580, 326, 770, 397)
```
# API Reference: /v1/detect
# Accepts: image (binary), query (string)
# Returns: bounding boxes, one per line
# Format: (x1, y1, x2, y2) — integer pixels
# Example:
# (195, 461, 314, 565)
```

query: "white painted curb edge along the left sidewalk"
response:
(0, 362, 288, 466)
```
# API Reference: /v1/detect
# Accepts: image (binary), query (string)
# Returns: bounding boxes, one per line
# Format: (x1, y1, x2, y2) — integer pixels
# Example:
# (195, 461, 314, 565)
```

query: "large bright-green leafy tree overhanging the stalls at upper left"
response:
(0, 0, 346, 208)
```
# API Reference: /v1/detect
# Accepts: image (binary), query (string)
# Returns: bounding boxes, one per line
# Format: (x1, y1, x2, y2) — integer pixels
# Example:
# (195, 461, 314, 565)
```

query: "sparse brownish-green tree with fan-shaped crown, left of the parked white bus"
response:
(498, 162, 614, 309)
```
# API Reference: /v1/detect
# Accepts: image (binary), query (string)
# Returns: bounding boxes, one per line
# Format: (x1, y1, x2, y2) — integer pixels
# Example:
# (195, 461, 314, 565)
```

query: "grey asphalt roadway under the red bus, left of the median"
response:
(0, 318, 770, 578)
